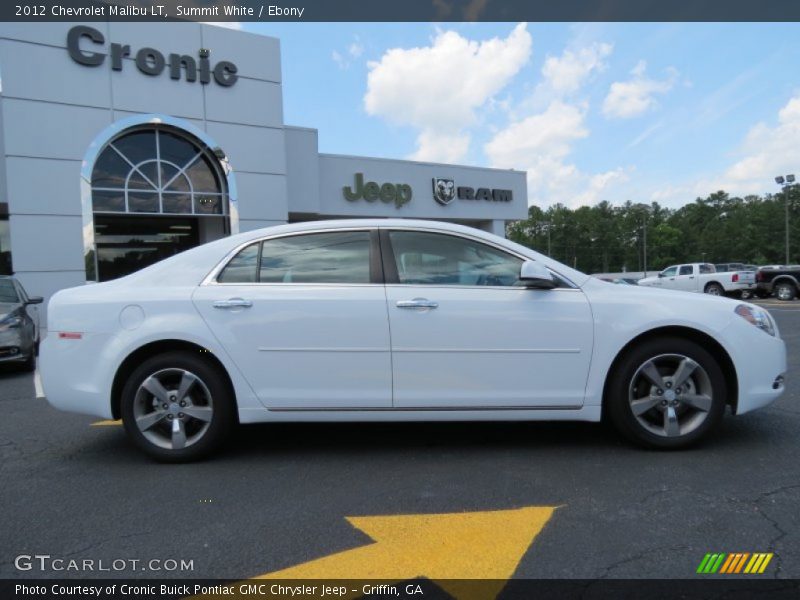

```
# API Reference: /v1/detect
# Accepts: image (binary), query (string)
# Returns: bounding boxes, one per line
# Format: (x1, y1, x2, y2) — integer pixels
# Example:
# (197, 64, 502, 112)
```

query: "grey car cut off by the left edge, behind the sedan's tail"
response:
(0, 277, 42, 371)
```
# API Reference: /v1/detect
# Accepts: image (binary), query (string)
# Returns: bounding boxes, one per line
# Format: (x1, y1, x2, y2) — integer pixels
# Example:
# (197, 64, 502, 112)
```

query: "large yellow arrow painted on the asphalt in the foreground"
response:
(248, 506, 557, 599)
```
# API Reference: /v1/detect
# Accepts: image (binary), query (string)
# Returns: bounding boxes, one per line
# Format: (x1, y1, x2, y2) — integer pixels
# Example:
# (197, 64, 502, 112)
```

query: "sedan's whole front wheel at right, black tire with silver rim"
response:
(604, 337, 728, 450)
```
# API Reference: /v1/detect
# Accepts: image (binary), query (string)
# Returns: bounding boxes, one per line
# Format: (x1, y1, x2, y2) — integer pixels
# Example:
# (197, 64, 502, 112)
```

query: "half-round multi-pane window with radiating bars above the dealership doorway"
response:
(91, 126, 228, 215)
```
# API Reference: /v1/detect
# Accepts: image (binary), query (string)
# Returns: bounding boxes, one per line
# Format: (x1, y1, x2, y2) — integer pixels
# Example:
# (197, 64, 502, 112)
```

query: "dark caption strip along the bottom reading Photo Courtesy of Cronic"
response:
(0, 576, 800, 600)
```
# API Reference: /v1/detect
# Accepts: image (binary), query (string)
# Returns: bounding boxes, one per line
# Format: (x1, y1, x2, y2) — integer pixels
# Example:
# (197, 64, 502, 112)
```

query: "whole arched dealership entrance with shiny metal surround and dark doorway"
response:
(81, 123, 233, 281)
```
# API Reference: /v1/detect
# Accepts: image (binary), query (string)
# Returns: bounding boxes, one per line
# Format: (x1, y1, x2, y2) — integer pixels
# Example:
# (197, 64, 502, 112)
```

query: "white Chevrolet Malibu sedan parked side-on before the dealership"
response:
(41, 219, 786, 461)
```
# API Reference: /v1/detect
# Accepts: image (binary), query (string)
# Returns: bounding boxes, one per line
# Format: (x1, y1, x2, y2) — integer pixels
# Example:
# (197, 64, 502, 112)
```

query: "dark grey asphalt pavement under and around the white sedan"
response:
(0, 300, 800, 579)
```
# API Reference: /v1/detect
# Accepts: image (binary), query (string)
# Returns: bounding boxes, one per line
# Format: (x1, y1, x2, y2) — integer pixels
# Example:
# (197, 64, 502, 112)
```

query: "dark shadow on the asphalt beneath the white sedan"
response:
(73, 406, 792, 465)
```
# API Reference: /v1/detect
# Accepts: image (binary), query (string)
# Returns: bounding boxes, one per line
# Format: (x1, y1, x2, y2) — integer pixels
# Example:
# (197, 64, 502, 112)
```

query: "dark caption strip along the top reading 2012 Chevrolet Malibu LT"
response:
(0, 0, 800, 22)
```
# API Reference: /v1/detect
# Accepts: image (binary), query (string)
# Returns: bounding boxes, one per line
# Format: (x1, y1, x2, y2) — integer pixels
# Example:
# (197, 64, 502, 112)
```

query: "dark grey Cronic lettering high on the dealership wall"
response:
(67, 25, 239, 87)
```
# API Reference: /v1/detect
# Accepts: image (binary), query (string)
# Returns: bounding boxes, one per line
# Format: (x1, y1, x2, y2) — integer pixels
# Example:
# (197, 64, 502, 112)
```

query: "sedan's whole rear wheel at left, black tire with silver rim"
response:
(120, 352, 236, 463)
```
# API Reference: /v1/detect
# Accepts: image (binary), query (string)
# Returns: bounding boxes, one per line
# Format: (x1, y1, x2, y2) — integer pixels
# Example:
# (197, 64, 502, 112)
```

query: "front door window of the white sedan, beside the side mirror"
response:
(389, 231, 522, 286)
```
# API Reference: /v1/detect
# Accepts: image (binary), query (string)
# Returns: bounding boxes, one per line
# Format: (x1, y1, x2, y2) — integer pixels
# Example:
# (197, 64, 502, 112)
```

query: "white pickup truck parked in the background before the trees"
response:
(639, 263, 756, 296)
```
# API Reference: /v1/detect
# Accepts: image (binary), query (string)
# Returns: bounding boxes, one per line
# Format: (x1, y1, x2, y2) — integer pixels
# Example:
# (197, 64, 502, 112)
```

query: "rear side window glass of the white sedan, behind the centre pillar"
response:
(217, 231, 370, 284)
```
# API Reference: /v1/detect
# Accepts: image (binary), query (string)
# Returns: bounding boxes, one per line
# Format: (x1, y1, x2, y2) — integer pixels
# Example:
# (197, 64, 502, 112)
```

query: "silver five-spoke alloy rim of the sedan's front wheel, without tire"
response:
(628, 354, 714, 437)
